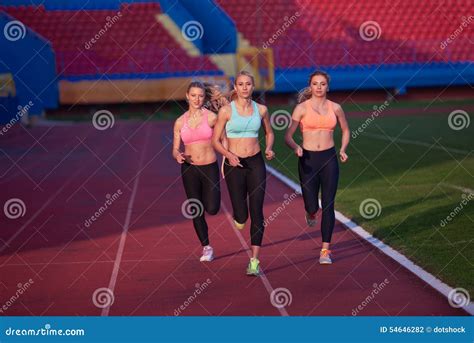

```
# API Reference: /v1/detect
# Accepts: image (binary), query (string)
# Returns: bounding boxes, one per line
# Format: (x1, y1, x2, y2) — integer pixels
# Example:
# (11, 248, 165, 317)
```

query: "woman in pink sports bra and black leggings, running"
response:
(173, 82, 226, 262)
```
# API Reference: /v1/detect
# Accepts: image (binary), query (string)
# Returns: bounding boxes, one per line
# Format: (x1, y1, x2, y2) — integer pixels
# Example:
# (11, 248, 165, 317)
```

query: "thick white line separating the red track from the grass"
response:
(267, 165, 474, 315)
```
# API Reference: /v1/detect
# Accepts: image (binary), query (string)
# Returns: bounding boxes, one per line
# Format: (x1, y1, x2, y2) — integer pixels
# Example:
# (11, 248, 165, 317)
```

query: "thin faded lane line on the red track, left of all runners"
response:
(101, 127, 149, 316)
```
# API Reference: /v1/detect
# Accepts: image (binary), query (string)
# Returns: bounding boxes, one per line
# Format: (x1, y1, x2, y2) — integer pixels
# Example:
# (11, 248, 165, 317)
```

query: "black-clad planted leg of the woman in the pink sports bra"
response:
(181, 162, 209, 246)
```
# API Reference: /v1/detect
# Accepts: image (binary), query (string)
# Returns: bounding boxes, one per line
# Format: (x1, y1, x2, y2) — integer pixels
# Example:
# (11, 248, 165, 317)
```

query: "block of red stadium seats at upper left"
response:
(0, 3, 219, 76)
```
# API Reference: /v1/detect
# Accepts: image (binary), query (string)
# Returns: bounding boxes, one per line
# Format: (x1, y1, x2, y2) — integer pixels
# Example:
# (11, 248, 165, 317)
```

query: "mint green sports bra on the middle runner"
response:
(225, 101, 262, 138)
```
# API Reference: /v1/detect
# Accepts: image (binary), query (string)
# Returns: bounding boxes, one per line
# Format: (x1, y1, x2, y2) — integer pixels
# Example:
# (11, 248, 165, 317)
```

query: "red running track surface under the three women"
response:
(0, 122, 466, 316)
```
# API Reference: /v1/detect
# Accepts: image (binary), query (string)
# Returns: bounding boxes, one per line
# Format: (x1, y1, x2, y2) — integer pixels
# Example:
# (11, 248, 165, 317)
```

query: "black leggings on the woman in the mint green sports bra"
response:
(224, 152, 267, 246)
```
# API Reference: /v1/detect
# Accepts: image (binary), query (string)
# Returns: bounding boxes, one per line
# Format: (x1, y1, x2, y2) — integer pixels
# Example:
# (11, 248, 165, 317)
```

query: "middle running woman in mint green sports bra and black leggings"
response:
(212, 71, 275, 276)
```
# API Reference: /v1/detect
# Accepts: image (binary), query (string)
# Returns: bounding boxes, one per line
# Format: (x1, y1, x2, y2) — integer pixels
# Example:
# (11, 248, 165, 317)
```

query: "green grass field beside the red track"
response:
(270, 101, 474, 294)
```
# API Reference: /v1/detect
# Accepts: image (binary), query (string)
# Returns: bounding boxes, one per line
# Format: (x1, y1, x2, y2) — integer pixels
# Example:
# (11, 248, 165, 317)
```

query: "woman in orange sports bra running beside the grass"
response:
(285, 71, 350, 264)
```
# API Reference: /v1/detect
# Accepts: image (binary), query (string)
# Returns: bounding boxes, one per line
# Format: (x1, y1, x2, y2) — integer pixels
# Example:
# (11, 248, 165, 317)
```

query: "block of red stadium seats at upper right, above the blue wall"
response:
(216, 0, 474, 68)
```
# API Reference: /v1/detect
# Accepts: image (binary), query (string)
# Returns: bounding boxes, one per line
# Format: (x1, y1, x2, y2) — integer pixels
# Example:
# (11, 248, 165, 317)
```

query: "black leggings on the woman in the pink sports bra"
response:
(181, 162, 221, 246)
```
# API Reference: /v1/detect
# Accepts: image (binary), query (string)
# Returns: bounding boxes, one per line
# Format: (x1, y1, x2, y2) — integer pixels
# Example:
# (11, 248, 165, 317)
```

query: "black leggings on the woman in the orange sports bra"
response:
(298, 147, 339, 243)
